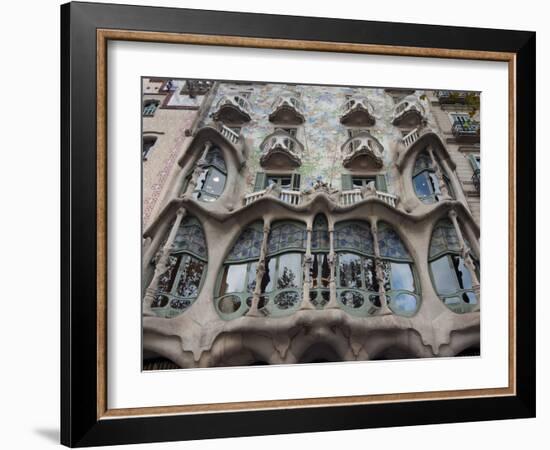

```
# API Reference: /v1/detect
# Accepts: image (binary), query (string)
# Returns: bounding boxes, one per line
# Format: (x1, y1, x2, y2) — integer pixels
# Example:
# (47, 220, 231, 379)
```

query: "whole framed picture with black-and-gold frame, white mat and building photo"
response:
(61, 3, 535, 447)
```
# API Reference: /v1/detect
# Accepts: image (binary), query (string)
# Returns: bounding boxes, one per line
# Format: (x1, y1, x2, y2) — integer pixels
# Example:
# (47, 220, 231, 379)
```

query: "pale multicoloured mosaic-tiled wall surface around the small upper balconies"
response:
(202, 82, 437, 192)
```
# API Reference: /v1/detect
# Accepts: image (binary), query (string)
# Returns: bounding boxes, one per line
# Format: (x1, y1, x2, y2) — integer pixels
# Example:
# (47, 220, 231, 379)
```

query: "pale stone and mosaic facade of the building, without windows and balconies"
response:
(143, 82, 479, 367)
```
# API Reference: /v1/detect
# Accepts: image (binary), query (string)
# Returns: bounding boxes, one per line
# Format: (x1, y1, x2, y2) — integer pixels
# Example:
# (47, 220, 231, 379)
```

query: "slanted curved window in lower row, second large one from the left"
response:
(216, 221, 263, 320)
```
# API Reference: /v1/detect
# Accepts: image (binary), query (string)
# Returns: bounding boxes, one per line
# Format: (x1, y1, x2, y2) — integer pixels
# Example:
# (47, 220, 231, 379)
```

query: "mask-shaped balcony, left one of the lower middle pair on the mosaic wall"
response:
(260, 130, 304, 169)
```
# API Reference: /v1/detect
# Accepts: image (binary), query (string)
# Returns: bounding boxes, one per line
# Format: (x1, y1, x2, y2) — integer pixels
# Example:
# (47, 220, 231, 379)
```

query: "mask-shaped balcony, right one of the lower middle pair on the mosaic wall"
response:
(342, 131, 384, 169)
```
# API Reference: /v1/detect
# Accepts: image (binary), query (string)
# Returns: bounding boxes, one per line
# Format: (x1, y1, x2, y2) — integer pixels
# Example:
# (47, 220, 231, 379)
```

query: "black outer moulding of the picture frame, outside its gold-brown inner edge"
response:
(60, 3, 536, 447)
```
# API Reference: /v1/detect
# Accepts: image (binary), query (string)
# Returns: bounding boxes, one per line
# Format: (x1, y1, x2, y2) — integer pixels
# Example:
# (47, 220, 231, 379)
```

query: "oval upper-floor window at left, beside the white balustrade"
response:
(193, 147, 227, 202)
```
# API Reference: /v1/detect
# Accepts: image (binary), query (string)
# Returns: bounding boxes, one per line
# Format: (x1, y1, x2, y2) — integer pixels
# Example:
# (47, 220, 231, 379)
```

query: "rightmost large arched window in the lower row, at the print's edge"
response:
(429, 219, 477, 313)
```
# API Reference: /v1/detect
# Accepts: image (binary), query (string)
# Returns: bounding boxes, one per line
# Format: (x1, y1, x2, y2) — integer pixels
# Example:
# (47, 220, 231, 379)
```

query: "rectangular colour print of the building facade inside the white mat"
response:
(143, 80, 480, 369)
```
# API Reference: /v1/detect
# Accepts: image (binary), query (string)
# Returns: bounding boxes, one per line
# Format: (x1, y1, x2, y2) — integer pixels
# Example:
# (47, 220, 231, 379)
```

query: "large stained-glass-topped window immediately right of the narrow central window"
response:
(334, 221, 380, 315)
